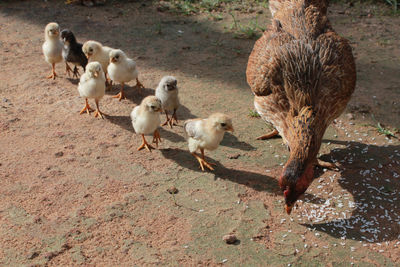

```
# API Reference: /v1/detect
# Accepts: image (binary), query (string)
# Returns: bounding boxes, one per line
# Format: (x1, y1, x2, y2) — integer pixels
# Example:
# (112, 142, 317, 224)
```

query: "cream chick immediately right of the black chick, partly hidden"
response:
(82, 41, 112, 85)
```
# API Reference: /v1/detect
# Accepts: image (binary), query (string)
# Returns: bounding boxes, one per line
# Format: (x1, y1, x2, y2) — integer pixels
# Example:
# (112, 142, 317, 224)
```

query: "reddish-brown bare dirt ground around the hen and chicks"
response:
(0, 0, 400, 266)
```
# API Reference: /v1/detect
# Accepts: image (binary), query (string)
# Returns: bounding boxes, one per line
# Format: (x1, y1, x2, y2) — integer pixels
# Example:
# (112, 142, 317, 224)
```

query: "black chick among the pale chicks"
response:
(61, 29, 88, 78)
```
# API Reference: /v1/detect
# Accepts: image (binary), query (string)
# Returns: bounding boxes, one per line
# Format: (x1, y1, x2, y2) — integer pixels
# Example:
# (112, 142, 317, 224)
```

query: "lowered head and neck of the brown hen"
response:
(279, 107, 326, 214)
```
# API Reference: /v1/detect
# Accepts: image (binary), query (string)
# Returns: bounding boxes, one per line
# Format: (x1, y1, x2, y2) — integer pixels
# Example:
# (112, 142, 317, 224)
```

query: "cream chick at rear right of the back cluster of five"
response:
(107, 49, 144, 101)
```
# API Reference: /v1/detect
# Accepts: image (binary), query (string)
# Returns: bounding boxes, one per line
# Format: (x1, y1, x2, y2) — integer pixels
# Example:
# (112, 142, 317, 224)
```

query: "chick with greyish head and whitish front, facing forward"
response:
(156, 76, 179, 128)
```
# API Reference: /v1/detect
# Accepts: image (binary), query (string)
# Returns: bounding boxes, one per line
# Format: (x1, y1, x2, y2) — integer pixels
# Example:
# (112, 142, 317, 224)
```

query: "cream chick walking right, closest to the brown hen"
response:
(183, 113, 233, 171)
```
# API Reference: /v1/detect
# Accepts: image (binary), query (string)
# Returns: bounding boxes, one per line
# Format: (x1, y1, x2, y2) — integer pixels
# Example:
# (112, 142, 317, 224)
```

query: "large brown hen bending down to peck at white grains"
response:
(246, 0, 356, 214)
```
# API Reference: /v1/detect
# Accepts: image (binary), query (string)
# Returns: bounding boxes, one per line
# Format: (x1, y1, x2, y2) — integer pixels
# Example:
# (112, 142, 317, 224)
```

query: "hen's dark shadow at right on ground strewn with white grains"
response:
(307, 140, 400, 242)
